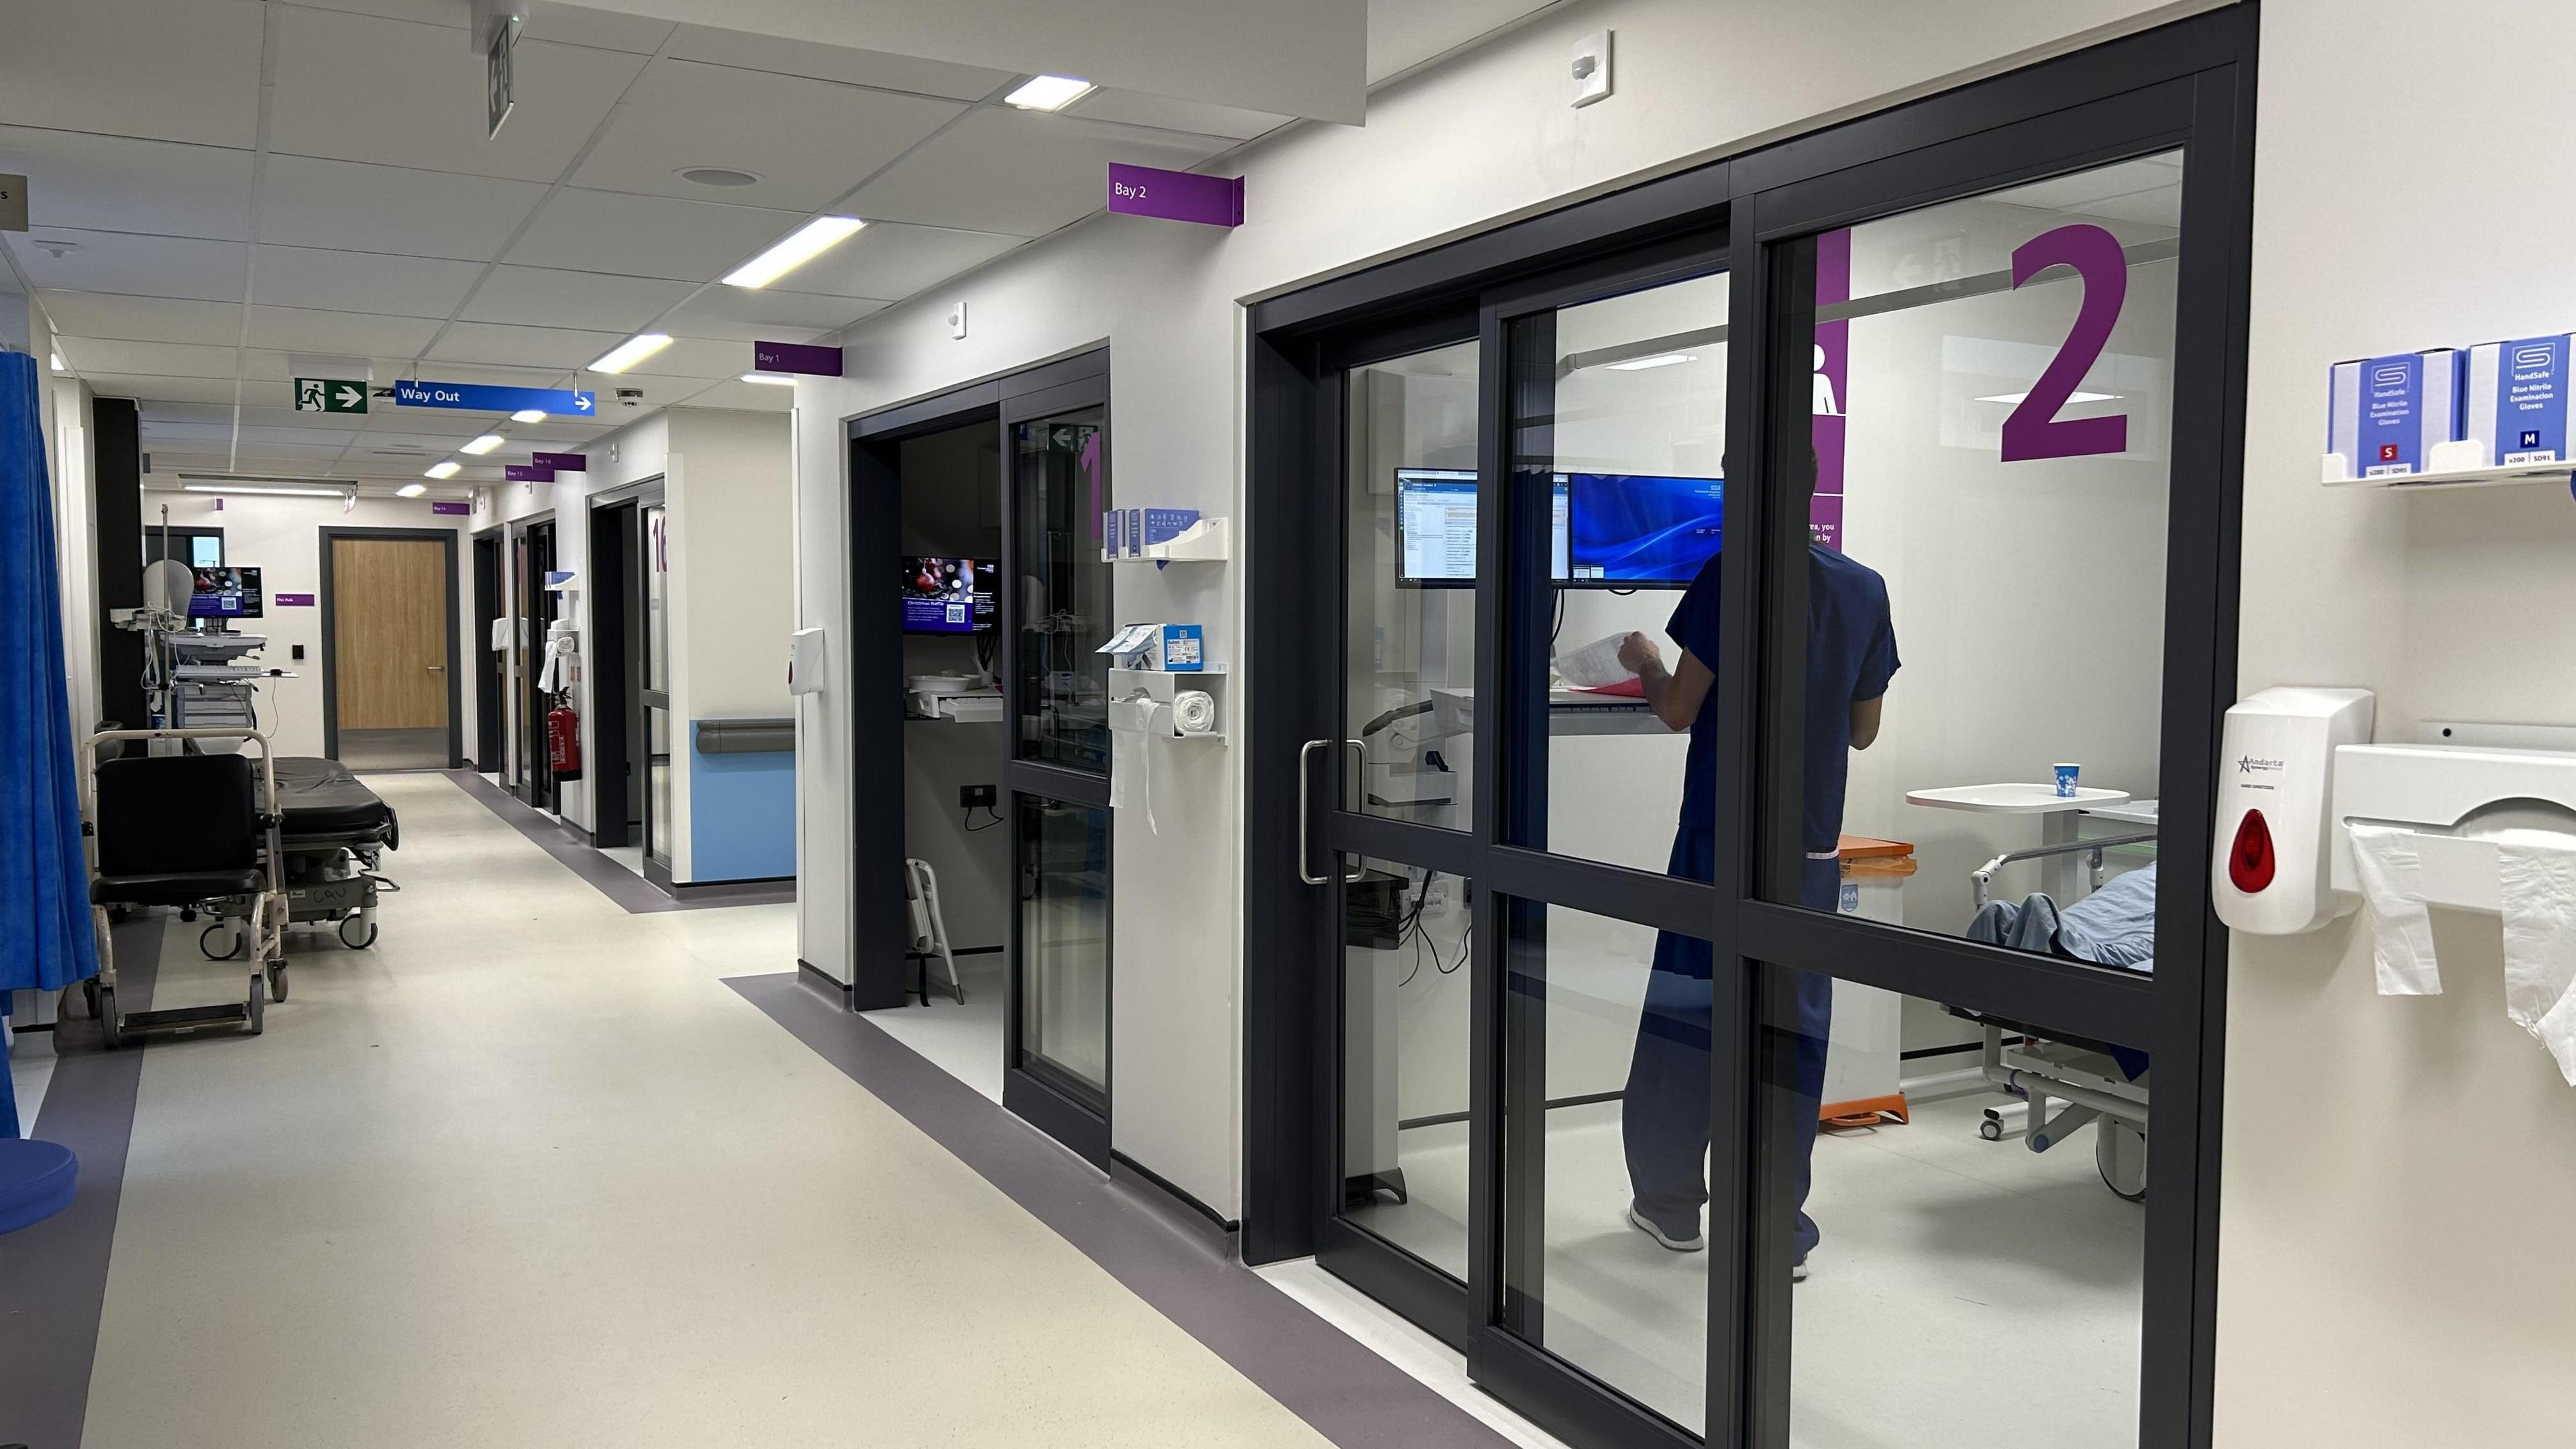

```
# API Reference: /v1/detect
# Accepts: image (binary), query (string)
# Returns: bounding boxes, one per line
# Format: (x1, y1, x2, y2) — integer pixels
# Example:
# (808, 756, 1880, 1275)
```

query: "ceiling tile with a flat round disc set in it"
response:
(572, 59, 966, 211)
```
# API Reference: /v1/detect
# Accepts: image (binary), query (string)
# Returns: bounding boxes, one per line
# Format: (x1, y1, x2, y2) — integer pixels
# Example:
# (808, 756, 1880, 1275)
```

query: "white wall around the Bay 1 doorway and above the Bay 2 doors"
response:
(796, 0, 2208, 1217)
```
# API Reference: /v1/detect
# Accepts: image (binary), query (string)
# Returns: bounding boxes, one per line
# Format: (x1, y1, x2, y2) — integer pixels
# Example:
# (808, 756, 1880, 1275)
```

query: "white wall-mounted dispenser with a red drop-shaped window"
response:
(2210, 688, 2373, 936)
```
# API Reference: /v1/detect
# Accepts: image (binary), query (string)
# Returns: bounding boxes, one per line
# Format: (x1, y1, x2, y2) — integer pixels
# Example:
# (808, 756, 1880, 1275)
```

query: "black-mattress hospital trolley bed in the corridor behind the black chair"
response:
(199, 755, 402, 964)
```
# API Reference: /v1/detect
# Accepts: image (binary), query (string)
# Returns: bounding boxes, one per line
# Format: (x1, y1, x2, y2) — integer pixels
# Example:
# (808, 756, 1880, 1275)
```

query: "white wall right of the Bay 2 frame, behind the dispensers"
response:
(2218, 0, 2576, 1449)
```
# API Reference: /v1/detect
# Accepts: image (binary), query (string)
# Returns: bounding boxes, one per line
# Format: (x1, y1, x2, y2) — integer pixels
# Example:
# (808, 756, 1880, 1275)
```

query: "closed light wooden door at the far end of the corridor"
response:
(330, 539, 451, 733)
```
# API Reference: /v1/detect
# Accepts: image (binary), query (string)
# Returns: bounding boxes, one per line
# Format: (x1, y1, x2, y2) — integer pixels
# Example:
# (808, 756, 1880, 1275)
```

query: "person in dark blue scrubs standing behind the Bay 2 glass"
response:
(1620, 544, 1896, 1279)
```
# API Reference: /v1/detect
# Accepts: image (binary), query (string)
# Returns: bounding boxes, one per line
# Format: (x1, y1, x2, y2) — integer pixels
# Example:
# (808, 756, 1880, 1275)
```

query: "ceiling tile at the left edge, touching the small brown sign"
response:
(0, 126, 250, 242)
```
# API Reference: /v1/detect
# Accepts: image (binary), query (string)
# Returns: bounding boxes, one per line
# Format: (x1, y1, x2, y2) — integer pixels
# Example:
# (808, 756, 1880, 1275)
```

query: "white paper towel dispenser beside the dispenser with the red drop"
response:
(2334, 724, 2576, 913)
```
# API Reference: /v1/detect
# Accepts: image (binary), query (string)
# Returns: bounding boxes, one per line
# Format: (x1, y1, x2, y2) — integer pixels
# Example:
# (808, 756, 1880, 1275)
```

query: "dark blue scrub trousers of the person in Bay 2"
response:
(1620, 825, 1842, 1263)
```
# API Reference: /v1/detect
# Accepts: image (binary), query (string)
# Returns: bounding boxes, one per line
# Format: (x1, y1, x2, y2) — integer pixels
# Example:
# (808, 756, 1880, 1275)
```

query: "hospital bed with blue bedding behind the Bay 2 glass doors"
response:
(1950, 833, 2156, 1201)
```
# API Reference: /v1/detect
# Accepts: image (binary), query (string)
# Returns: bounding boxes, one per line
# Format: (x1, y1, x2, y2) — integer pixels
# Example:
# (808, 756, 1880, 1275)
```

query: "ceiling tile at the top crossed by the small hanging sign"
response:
(268, 5, 644, 180)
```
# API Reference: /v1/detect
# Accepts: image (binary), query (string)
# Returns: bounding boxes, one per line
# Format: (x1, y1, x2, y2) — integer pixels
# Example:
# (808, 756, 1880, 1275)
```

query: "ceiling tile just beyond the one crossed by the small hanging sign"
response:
(260, 155, 546, 260)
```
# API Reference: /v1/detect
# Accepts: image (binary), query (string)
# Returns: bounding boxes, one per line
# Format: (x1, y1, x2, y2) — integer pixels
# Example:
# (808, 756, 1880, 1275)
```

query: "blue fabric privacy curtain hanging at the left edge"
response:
(0, 351, 98, 1137)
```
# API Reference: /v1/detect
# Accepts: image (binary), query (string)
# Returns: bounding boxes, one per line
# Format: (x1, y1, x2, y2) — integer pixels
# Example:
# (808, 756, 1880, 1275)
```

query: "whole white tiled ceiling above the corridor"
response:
(0, 0, 1546, 482)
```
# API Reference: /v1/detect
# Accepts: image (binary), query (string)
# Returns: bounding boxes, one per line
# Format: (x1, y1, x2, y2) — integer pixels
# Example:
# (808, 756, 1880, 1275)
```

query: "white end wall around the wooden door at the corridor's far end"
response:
(144, 474, 476, 755)
